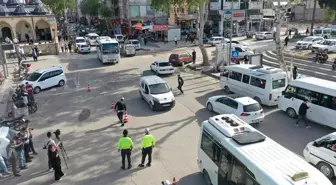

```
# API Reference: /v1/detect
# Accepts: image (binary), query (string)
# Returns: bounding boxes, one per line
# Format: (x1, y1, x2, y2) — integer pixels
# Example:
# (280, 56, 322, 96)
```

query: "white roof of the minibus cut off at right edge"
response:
(289, 77, 336, 96)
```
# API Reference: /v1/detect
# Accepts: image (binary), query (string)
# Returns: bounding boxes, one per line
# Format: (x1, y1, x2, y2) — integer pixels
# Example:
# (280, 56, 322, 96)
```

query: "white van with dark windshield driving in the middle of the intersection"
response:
(139, 75, 175, 110)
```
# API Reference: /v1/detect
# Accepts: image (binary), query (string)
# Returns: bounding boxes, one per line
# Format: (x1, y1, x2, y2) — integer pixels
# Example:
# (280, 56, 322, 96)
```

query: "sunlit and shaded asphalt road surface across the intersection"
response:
(0, 45, 334, 185)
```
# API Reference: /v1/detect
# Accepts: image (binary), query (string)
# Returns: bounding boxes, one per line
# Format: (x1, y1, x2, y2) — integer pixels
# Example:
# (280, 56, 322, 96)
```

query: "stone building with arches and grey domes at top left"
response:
(0, 0, 58, 43)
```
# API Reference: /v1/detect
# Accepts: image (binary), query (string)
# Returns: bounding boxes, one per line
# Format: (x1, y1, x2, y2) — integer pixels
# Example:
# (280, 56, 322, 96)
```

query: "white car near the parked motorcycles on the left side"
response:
(21, 66, 67, 94)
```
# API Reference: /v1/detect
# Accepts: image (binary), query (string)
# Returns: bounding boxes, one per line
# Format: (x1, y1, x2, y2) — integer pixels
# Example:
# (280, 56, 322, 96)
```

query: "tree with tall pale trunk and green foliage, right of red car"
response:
(151, 0, 210, 66)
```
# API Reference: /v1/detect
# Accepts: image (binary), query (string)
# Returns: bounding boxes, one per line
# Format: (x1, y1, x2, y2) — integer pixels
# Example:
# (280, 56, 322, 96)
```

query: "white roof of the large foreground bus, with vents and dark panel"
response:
(202, 114, 331, 185)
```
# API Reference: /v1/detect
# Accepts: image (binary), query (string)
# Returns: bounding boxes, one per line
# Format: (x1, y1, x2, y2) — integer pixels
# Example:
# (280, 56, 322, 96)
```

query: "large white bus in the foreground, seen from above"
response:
(196, 114, 332, 185)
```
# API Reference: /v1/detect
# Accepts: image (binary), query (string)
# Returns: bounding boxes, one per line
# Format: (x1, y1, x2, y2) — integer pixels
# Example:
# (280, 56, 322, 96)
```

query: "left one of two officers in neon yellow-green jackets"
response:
(118, 129, 134, 170)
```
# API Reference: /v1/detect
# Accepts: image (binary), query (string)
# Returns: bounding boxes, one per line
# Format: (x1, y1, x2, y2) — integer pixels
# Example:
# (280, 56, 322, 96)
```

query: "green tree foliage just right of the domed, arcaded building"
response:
(42, 0, 76, 15)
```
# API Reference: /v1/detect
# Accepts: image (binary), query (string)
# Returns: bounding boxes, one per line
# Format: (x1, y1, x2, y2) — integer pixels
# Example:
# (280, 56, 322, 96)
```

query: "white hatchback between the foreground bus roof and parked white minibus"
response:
(206, 95, 265, 124)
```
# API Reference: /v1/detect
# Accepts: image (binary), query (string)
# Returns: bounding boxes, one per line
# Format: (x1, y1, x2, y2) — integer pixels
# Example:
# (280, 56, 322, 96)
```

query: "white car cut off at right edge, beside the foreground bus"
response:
(303, 132, 336, 178)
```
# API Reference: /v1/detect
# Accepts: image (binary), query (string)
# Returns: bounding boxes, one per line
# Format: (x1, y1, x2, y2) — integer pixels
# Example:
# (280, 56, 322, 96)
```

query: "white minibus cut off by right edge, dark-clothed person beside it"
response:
(278, 77, 336, 128)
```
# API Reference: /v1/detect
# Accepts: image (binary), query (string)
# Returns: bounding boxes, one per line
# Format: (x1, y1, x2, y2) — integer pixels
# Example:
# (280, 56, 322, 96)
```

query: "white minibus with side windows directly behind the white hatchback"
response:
(220, 64, 287, 106)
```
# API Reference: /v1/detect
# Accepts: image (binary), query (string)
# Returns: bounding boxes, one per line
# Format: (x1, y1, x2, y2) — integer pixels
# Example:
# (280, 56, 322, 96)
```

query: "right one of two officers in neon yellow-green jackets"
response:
(139, 128, 156, 167)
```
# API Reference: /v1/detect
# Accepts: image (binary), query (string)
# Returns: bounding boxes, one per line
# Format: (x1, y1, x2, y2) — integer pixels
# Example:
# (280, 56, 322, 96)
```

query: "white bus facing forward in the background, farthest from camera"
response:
(97, 38, 120, 64)
